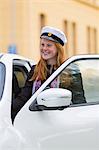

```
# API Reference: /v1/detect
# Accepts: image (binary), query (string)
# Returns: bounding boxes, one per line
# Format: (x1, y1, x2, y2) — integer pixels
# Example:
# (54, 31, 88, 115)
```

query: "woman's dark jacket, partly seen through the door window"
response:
(11, 66, 86, 121)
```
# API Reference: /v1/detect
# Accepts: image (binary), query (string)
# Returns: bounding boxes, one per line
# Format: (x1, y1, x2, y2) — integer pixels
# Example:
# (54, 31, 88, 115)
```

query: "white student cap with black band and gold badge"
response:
(40, 26, 67, 46)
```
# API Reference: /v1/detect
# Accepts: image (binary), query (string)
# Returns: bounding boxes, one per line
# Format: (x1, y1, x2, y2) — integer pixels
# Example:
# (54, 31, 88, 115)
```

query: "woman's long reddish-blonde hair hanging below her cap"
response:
(30, 43, 65, 81)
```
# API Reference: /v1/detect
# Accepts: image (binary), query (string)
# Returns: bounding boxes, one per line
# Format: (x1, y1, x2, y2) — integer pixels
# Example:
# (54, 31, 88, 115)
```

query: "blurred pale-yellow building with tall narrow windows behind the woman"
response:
(0, 0, 99, 60)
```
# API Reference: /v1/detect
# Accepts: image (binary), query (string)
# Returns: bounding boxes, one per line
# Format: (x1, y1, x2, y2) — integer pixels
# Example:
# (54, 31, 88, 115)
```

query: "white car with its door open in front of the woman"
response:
(0, 54, 99, 150)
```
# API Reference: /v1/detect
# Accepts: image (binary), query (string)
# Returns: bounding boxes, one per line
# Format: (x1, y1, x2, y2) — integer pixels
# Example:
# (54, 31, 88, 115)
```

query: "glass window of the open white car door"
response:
(44, 59, 99, 105)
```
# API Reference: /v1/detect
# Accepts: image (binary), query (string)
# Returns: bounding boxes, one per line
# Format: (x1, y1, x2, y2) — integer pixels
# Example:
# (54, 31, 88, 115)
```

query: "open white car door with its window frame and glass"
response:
(14, 56, 99, 150)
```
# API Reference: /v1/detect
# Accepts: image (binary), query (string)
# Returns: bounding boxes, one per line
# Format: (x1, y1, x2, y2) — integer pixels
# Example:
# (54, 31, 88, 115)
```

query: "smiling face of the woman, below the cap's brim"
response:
(40, 38, 57, 65)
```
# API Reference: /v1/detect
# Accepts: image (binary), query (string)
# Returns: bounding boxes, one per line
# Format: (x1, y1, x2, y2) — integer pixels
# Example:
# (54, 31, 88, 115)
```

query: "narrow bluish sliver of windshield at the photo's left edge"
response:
(0, 63, 6, 100)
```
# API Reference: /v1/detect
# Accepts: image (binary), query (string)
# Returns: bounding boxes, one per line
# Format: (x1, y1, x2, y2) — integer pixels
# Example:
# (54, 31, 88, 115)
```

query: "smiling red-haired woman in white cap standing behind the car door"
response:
(12, 26, 86, 120)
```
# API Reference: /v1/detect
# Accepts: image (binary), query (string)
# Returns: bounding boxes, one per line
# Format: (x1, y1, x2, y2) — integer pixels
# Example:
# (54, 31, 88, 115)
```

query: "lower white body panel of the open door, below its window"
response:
(15, 103, 99, 150)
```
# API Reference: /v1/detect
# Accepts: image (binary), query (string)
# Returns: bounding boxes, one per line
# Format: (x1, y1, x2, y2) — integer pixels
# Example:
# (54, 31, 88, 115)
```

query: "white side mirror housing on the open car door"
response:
(37, 88, 71, 107)
